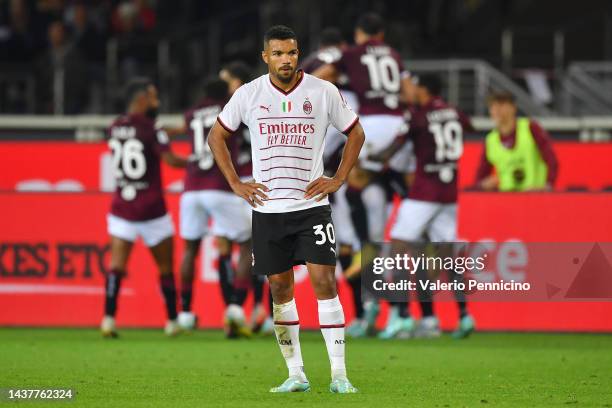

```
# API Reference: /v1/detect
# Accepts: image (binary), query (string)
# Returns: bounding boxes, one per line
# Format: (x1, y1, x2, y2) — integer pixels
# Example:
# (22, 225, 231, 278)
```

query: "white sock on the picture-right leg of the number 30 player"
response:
(318, 296, 346, 379)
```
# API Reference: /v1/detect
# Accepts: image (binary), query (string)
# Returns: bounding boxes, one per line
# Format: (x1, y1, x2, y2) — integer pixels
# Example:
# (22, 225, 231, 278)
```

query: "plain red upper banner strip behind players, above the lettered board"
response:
(0, 142, 612, 191)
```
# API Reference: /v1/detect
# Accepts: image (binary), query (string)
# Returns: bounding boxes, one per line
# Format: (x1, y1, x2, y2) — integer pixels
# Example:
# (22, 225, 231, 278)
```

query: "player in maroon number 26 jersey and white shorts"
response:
(100, 78, 187, 337)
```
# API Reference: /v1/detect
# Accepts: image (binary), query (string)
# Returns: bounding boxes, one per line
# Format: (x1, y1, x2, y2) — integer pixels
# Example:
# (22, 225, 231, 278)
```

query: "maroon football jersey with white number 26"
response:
(108, 115, 170, 221)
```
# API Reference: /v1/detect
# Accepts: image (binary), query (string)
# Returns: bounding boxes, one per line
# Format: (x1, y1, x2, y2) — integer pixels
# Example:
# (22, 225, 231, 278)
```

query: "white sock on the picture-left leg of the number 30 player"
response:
(272, 299, 306, 381)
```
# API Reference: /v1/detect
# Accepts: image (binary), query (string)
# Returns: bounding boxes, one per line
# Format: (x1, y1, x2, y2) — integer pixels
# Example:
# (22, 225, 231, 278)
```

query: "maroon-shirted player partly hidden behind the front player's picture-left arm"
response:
(174, 63, 251, 338)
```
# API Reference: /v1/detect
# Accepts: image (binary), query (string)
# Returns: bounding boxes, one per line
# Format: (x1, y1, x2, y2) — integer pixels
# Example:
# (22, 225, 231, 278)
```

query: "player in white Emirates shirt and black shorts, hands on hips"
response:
(208, 26, 365, 393)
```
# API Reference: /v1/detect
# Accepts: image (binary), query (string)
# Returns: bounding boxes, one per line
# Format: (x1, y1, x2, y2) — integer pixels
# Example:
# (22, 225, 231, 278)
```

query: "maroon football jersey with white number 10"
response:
(334, 40, 408, 116)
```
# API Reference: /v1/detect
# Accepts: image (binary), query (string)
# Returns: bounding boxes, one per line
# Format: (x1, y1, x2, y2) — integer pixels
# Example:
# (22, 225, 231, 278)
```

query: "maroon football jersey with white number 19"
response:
(408, 98, 472, 203)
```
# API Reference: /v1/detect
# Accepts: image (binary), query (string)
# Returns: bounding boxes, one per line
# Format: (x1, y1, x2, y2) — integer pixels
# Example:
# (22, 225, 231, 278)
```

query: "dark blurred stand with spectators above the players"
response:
(0, 0, 612, 114)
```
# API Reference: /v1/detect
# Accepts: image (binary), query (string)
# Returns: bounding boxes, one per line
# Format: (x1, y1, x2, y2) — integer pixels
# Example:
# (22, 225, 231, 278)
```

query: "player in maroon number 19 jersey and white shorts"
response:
(385, 75, 475, 338)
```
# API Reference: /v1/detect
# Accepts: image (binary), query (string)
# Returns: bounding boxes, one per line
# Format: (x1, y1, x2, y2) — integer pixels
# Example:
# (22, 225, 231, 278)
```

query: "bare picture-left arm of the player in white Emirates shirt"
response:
(208, 122, 268, 207)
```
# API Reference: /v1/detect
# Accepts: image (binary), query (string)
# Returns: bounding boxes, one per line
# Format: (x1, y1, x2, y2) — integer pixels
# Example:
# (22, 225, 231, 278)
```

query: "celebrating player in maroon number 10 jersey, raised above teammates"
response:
(313, 13, 413, 336)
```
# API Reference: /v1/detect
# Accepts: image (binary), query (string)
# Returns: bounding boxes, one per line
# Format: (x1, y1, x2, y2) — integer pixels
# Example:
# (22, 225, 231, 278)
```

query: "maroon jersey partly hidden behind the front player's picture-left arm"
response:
(185, 99, 252, 191)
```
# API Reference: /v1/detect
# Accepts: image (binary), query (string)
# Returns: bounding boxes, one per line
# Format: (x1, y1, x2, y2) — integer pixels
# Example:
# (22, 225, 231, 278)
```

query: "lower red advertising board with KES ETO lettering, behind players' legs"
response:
(0, 193, 612, 332)
